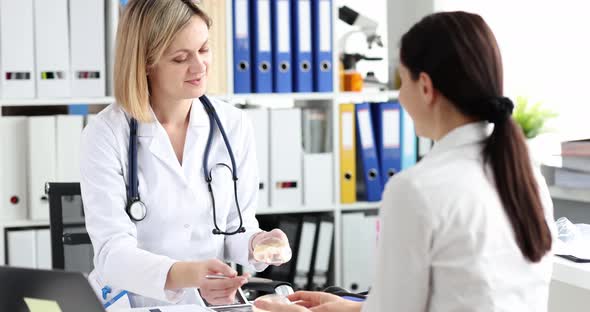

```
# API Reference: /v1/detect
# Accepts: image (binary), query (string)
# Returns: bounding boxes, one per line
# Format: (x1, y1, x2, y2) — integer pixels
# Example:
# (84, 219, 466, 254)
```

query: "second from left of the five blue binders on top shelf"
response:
(250, 0, 272, 93)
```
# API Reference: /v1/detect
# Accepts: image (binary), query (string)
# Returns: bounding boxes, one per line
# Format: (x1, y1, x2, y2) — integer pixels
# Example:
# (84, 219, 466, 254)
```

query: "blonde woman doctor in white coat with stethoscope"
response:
(81, 0, 289, 306)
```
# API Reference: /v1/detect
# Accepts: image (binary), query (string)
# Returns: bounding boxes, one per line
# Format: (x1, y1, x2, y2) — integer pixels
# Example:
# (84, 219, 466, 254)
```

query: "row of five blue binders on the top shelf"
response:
(233, 0, 333, 93)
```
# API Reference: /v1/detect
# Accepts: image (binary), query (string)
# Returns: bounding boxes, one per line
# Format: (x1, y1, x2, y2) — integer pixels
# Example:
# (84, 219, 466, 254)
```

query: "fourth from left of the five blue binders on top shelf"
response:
(291, 0, 313, 92)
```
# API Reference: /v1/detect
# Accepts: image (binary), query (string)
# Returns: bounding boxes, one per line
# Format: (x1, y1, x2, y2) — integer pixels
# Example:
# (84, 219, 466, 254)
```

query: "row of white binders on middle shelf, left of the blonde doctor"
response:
(0, 115, 93, 220)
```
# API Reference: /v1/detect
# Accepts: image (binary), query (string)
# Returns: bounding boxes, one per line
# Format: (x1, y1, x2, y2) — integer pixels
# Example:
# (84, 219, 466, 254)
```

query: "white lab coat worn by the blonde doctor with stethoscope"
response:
(80, 99, 266, 306)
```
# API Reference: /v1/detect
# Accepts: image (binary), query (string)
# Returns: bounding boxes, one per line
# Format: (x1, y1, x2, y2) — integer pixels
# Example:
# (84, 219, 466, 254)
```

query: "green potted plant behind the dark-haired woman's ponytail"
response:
(512, 96, 558, 165)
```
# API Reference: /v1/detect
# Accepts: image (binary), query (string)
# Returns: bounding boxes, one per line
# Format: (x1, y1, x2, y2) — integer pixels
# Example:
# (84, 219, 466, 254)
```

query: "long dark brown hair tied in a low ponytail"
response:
(400, 12, 551, 262)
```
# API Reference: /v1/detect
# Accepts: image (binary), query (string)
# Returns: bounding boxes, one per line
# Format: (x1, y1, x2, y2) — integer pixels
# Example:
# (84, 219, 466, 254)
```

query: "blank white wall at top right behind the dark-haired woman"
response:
(435, 0, 590, 140)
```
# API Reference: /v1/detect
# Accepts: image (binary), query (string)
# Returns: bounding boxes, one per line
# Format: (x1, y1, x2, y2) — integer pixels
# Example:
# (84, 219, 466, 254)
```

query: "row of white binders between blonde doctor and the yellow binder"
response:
(245, 108, 334, 209)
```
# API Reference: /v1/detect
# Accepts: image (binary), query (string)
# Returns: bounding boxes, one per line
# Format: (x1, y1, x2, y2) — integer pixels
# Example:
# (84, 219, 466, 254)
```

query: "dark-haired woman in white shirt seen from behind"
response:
(256, 12, 553, 312)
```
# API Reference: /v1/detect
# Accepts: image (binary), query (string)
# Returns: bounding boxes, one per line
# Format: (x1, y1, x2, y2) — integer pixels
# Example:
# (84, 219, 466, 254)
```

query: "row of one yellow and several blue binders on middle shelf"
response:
(339, 101, 417, 203)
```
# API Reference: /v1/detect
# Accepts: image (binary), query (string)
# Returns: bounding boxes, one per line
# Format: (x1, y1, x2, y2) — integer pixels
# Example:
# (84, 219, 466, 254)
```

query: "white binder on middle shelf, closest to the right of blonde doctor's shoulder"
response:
(245, 108, 269, 209)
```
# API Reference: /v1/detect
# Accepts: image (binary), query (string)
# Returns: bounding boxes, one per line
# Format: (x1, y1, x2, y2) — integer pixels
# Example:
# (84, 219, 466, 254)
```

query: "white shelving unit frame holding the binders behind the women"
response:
(0, 0, 432, 285)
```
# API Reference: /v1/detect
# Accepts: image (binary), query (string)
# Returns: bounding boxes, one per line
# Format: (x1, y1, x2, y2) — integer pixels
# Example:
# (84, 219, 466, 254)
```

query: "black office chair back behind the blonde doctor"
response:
(45, 182, 94, 274)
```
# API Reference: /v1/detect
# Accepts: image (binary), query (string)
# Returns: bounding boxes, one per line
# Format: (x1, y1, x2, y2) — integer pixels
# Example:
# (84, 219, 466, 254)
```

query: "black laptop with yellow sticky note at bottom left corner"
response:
(0, 266, 105, 312)
